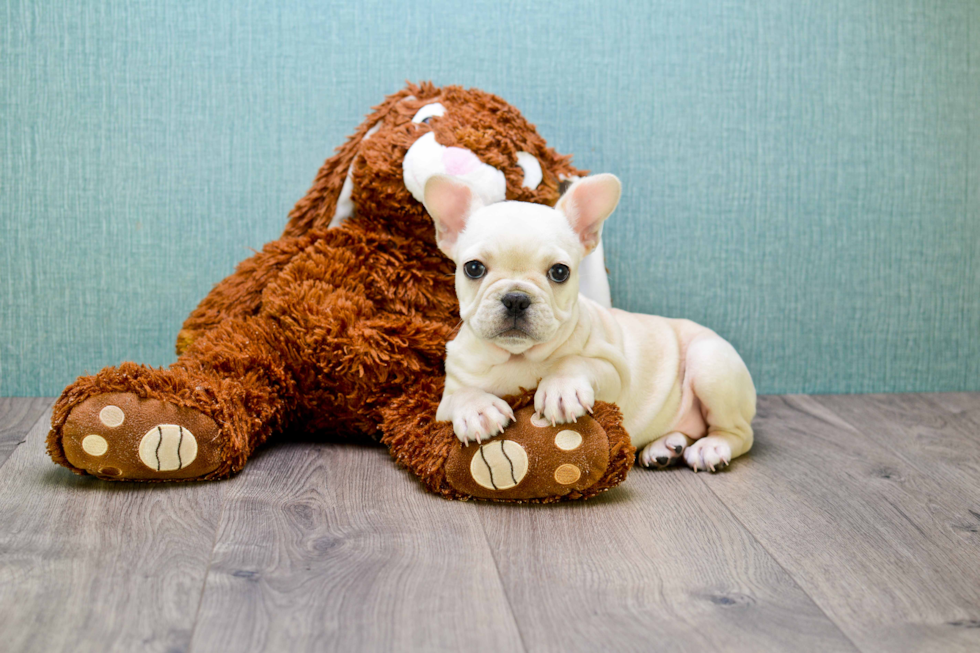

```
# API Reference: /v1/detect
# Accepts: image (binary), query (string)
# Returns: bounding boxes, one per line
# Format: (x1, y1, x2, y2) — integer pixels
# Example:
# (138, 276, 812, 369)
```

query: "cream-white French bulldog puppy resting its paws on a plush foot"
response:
(424, 174, 756, 471)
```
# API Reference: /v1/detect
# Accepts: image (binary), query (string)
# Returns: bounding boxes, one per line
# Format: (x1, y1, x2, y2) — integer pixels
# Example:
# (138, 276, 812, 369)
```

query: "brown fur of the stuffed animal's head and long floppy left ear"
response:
(177, 82, 587, 354)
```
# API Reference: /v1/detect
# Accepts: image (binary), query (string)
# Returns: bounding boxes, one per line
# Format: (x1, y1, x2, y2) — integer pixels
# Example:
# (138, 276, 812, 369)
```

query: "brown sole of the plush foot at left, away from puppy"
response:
(61, 393, 222, 481)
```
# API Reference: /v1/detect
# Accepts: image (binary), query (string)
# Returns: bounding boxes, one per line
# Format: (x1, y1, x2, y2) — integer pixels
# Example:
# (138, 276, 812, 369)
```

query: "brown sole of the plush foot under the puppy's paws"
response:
(446, 406, 610, 501)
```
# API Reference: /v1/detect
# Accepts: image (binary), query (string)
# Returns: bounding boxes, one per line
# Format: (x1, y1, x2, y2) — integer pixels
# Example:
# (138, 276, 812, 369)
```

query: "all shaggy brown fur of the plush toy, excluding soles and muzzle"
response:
(48, 83, 633, 501)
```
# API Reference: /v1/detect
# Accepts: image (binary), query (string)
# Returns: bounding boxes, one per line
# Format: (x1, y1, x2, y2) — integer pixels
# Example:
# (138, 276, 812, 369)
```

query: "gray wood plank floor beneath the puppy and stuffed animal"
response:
(0, 394, 980, 653)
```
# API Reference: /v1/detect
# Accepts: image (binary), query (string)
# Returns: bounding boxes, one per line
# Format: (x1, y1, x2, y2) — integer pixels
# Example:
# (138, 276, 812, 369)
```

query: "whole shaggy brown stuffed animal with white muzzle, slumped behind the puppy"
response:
(48, 83, 635, 502)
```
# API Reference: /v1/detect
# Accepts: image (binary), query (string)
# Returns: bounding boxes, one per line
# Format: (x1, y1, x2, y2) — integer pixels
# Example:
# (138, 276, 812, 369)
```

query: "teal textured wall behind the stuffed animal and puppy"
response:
(0, 0, 980, 395)
